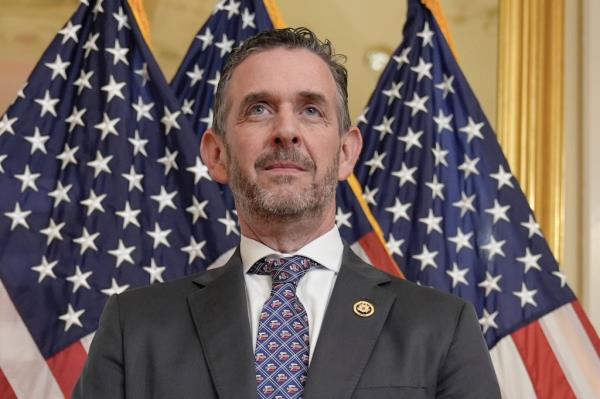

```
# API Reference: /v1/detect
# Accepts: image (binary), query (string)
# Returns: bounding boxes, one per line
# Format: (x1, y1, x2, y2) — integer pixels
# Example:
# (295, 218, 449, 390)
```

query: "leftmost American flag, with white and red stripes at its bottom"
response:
(0, 0, 239, 398)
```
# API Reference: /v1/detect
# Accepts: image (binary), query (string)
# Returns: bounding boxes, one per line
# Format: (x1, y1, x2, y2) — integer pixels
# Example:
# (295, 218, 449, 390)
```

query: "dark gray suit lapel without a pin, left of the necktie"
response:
(188, 249, 256, 399)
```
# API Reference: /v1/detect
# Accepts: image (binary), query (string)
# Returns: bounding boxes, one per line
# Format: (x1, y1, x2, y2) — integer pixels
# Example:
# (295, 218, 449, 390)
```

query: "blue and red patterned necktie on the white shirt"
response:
(249, 256, 316, 399)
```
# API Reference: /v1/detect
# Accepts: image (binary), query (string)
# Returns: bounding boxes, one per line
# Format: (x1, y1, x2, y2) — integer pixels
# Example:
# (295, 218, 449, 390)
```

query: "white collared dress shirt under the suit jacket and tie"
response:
(240, 226, 344, 362)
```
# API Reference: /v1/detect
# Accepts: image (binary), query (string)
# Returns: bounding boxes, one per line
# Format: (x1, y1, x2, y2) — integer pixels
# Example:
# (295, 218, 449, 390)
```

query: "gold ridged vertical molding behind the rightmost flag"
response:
(497, 0, 564, 261)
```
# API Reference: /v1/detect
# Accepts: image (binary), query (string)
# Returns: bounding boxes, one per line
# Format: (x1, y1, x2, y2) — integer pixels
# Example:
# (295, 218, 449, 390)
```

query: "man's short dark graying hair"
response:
(213, 27, 350, 135)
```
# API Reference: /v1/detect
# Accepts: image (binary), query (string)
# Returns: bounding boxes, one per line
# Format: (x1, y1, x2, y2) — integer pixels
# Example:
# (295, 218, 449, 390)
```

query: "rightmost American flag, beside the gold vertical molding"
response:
(355, 0, 600, 398)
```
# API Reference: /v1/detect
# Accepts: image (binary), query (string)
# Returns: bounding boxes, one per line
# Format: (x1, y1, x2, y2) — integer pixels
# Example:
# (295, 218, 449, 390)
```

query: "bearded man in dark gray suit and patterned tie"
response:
(74, 28, 500, 399)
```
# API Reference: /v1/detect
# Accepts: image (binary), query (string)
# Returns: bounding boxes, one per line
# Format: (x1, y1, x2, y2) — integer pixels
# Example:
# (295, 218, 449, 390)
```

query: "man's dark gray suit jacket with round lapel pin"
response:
(73, 248, 500, 399)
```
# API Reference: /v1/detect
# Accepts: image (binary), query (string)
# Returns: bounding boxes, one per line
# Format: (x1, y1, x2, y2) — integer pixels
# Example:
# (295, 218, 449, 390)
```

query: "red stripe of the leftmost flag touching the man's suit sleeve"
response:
(47, 341, 87, 398)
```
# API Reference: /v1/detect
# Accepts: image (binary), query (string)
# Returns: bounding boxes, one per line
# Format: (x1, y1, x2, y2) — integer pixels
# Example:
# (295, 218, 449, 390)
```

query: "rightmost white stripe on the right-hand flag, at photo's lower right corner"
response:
(539, 304, 600, 398)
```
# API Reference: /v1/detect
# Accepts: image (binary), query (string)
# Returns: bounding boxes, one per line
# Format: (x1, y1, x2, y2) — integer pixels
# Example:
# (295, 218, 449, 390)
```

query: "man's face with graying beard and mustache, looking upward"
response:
(218, 49, 346, 218)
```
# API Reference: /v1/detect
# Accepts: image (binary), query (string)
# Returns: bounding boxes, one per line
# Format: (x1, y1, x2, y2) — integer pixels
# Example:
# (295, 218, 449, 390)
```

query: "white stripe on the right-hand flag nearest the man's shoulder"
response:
(490, 336, 536, 399)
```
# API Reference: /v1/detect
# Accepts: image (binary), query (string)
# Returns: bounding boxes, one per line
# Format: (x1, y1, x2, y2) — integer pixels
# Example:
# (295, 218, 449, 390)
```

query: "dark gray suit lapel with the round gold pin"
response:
(304, 247, 395, 399)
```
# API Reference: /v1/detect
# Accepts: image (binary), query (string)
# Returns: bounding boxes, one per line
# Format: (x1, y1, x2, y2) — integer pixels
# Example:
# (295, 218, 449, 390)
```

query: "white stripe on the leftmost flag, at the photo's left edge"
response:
(0, 281, 64, 399)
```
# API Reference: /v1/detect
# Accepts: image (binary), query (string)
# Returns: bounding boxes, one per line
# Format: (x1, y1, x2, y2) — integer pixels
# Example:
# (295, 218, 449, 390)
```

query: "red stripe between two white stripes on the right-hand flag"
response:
(511, 321, 575, 399)
